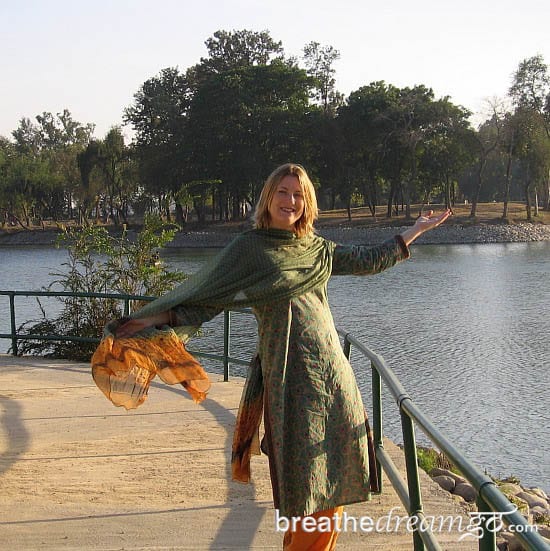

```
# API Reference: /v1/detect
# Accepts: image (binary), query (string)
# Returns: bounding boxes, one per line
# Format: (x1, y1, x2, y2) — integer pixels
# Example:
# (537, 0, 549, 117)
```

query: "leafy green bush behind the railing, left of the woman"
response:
(18, 217, 186, 361)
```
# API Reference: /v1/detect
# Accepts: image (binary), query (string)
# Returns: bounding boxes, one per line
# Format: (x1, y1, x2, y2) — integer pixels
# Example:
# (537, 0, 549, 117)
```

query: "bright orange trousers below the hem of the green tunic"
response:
(283, 506, 344, 551)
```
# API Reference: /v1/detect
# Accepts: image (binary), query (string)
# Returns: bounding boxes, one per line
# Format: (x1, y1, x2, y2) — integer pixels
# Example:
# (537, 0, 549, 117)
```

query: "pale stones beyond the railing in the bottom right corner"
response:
(429, 468, 550, 551)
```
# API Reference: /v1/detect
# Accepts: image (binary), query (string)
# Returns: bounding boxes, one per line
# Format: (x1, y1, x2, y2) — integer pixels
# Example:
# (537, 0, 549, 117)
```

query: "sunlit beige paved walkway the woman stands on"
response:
(0, 355, 477, 551)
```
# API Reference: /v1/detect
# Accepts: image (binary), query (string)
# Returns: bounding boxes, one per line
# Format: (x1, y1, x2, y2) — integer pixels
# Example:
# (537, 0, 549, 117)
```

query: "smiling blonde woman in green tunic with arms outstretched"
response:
(100, 164, 450, 550)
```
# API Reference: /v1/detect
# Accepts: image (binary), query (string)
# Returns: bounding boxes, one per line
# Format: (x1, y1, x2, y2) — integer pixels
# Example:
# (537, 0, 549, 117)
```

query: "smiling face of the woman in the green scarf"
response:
(268, 174, 305, 231)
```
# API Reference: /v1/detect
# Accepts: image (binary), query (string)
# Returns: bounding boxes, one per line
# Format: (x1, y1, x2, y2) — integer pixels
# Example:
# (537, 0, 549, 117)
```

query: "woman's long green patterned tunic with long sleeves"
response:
(172, 231, 409, 517)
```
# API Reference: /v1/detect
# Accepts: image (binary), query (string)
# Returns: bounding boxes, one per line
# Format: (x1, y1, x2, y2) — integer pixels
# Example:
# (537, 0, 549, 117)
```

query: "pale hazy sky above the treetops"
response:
(0, 0, 550, 138)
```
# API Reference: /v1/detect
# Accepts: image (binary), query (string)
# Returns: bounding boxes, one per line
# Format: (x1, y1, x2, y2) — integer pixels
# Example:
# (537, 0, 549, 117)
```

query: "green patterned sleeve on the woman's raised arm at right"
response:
(332, 235, 410, 275)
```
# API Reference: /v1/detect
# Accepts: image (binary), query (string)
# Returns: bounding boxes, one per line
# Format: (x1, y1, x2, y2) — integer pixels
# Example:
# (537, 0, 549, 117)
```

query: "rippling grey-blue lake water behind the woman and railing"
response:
(0, 241, 550, 491)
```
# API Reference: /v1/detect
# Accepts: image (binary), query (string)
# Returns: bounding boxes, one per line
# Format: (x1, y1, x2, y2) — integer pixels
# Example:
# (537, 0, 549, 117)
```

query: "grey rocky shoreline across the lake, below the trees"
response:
(0, 222, 550, 248)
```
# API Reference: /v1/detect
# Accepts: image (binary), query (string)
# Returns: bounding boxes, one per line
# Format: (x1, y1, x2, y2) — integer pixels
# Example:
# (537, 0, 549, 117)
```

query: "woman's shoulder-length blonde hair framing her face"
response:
(254, 163, 319, 237)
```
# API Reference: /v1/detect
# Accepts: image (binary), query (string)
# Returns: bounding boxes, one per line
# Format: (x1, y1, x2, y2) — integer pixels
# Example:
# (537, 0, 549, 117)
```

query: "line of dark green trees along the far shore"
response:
(0, 30, 550, 227)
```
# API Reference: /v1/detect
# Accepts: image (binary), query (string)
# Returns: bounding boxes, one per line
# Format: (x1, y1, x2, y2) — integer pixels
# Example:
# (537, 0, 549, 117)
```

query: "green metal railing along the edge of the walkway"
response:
(0, 291, 550, 551)
